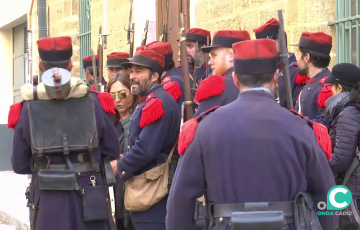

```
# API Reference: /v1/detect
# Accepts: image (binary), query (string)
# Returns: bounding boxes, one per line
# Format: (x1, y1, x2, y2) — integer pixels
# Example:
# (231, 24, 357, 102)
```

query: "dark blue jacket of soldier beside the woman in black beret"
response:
(295, 68, 331, 120)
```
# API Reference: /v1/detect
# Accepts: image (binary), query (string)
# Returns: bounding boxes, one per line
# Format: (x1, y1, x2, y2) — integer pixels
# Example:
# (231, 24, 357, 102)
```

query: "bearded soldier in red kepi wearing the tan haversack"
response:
(114, 50, 180, 230)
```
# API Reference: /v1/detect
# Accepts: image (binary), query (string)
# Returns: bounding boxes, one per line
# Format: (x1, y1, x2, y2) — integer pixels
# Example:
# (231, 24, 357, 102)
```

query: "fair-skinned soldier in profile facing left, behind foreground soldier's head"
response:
(195, 30, 250, 116)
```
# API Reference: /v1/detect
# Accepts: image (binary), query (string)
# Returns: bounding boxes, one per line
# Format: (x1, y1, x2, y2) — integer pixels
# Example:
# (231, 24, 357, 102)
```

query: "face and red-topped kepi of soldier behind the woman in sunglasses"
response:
(105, 52, 130, 81)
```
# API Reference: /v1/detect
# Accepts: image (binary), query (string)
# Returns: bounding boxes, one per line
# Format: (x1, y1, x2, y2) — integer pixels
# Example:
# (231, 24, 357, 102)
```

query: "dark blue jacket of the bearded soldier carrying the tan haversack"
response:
(118, 84, 180, 223)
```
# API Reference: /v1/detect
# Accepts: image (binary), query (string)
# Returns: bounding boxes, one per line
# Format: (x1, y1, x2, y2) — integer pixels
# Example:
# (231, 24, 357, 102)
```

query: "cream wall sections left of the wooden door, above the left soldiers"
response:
(32, 0, 130, 78)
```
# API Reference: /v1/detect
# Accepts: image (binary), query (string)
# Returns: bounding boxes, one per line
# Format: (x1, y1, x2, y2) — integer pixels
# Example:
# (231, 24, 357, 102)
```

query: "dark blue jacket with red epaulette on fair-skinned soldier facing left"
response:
(194, 68, 239, 117)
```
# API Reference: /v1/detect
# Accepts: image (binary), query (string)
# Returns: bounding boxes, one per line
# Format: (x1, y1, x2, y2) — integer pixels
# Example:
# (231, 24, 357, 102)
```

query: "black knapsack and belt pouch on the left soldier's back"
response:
(27, 95, 100, 190)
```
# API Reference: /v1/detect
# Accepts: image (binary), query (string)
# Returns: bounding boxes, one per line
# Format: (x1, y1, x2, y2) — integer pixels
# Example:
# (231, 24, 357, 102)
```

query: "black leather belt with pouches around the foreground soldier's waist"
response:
(208, 192, 322, 230)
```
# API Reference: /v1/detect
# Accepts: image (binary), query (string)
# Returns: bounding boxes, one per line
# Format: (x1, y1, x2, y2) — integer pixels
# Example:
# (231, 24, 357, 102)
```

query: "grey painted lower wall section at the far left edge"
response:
(0, 124, 14, 171)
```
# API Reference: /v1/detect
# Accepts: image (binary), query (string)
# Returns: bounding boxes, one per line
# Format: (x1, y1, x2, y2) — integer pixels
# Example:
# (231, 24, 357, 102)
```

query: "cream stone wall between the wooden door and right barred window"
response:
(191, 0, 336, 66)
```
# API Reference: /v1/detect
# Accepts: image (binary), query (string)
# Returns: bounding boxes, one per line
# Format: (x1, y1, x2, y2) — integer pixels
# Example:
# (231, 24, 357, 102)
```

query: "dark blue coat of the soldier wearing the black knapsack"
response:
(11, 93, 119, 230)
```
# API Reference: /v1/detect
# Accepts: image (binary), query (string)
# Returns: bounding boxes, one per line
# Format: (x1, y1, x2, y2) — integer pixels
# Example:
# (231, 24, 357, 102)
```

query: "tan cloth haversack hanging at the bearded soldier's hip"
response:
(124, 142, 177, 212)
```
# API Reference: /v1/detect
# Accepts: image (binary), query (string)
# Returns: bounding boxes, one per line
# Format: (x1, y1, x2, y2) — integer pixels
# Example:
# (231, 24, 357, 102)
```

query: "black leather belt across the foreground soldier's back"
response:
(210, 201, 294, 218)
